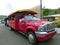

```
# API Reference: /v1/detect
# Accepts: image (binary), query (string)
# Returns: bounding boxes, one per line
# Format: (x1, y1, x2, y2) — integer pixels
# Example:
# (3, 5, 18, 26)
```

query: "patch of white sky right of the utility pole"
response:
(42, 0, 60, 9)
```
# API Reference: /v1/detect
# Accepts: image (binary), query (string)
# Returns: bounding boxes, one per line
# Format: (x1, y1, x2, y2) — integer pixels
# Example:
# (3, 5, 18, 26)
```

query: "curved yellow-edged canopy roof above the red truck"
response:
(8, 9, 38, 17)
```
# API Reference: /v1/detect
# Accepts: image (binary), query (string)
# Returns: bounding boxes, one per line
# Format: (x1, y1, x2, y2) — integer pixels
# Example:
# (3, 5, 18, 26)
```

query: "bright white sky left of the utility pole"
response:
(0, 0, 40, 15)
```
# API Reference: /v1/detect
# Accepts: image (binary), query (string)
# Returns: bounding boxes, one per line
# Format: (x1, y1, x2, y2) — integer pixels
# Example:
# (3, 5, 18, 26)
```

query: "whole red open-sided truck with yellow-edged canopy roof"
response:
(8, 10, 57, 44)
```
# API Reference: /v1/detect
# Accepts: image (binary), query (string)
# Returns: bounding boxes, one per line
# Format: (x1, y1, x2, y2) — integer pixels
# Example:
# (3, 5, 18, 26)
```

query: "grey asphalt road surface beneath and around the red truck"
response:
(0, 25, 60, 45)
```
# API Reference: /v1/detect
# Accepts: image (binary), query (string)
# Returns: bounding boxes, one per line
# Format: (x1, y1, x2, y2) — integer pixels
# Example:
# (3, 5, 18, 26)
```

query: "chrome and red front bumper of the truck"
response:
(35, 31, 57, 41)
